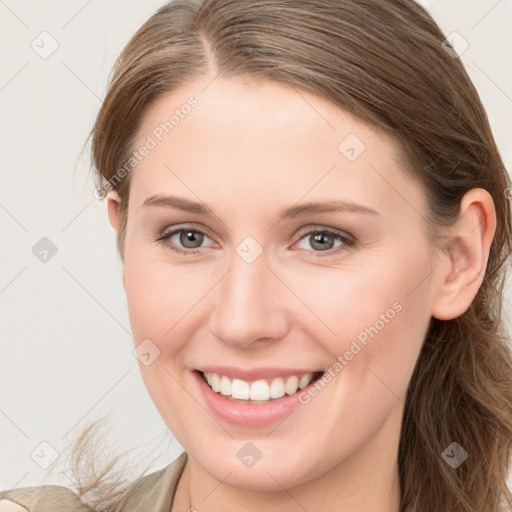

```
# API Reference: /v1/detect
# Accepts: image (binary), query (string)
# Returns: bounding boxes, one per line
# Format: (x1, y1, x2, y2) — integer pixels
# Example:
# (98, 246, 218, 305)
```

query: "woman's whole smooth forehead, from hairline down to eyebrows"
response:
(132, 77, 423, 224)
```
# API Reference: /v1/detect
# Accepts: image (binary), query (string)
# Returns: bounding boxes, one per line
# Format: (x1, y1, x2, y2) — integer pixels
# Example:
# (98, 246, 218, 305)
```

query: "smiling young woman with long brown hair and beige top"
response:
(0, 0, 512, 512)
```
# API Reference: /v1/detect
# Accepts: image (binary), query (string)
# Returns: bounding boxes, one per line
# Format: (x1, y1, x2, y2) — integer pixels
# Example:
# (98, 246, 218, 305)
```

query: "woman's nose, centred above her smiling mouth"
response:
(210, 250, 293, 348)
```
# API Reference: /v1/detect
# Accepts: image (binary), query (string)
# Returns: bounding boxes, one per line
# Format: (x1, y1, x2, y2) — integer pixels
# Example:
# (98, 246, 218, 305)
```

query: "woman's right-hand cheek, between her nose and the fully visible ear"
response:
(284, 252, 430, 388)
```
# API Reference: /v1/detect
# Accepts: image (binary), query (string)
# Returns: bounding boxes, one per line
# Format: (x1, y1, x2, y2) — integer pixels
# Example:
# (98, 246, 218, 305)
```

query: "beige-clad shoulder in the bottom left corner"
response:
(0, 485, 93, 512)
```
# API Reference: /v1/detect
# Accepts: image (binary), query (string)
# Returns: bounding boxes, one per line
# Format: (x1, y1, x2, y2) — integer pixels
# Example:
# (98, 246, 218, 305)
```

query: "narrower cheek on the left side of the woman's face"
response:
(124, 249, 204, 432)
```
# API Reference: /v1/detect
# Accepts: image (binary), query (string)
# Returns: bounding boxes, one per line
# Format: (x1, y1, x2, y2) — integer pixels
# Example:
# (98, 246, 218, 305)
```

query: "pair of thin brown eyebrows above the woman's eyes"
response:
(141, 195, 380, 219)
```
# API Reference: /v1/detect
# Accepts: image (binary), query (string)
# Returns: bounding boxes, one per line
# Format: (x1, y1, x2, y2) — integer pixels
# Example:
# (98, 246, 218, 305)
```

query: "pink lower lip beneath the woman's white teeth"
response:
(192, 370, 321, 427)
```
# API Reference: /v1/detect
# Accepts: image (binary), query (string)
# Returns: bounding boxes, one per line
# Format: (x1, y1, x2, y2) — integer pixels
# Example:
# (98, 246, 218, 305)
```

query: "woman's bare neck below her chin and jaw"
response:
(171, 403, 403, 512)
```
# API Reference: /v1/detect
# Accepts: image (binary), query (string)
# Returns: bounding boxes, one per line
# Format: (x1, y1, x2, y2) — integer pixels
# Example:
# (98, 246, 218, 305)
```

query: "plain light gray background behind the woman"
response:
(0, 0, 512, 489)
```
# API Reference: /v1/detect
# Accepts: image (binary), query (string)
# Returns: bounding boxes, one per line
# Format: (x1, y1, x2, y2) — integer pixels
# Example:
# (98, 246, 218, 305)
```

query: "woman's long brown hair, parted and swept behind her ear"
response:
(64, 0, 512, 512)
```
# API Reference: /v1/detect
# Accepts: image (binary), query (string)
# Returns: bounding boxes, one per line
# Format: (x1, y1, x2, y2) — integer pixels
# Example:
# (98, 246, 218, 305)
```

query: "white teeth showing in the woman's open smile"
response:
(194, 370, 325, 404)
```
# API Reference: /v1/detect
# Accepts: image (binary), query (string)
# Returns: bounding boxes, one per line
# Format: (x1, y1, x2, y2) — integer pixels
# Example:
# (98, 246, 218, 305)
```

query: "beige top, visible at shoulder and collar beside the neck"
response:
(0, 452, 188, 512)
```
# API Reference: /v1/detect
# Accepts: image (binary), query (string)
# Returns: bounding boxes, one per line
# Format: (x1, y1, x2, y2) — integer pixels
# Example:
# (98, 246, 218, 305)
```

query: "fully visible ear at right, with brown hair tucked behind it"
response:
(432, 188, 496, 320)
